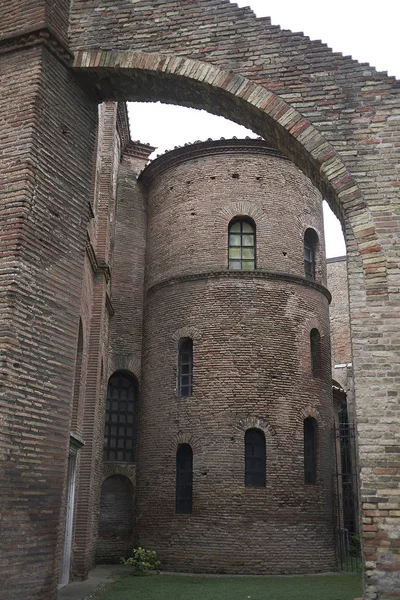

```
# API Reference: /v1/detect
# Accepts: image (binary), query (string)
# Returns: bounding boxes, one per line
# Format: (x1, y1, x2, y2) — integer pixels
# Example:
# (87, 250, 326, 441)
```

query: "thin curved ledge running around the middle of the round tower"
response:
(147, 269, 332, 303)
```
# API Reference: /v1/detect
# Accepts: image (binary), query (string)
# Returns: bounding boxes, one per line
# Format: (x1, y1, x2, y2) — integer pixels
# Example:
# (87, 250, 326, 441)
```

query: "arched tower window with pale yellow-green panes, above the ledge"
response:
(229, 217, 256, 271)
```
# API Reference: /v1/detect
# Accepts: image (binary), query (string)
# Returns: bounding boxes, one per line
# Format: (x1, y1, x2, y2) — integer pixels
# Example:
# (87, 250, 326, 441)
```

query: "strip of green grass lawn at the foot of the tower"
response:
(99, 573, 361, 600)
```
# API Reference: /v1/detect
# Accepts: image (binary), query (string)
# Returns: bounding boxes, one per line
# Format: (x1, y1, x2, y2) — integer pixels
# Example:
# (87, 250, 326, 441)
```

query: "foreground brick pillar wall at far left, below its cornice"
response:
(0, 45, 95, 600)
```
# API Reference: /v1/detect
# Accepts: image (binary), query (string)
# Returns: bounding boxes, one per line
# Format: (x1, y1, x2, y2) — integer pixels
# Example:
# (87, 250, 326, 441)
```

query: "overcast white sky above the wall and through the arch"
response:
(129, 0, 400, 257)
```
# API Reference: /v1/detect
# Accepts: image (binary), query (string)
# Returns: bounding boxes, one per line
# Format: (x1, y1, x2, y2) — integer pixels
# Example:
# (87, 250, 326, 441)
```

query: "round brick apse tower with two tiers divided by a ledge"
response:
(136, 140, 334, 574)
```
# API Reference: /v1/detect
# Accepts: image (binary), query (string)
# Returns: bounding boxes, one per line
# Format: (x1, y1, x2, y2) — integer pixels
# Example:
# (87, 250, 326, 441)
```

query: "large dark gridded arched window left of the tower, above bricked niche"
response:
(104, 372, 138, 462)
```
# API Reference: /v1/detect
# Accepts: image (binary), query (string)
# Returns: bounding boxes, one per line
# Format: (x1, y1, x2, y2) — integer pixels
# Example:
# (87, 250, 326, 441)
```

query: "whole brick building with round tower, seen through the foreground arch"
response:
(53, 103, 350, 583)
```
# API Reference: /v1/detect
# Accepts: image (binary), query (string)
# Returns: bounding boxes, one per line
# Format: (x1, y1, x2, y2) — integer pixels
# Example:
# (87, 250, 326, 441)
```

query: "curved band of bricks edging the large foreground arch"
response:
(73, 50, 387, 296)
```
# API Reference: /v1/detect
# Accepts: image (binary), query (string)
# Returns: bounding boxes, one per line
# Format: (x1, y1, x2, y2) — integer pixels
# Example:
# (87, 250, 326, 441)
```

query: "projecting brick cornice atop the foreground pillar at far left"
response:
(0, 23, 73, 66)
